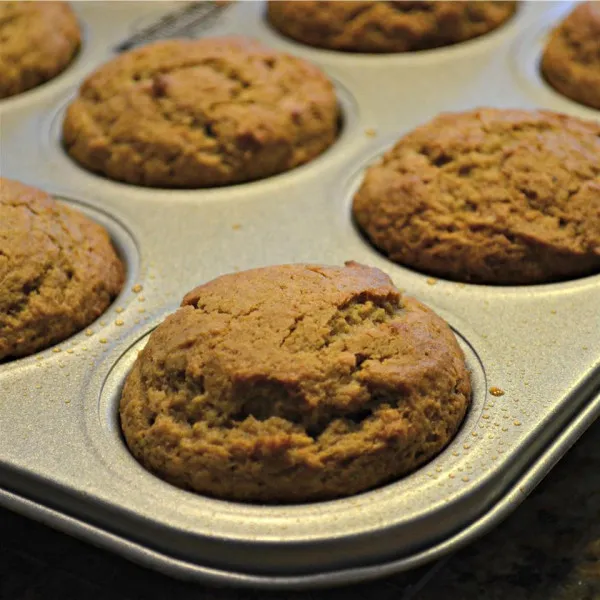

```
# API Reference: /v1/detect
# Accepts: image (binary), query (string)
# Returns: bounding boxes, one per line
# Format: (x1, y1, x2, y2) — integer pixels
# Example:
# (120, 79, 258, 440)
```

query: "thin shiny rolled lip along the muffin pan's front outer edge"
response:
(0, 382, 600, 590)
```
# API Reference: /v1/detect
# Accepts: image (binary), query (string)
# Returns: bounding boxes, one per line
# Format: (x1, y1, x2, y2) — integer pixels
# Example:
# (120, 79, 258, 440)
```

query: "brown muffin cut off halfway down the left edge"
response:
(0, 179, 124, 360)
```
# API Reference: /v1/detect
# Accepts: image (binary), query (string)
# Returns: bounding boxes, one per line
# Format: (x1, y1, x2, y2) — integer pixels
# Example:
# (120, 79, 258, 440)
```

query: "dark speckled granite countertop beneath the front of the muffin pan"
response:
(0, 422, 600, 600)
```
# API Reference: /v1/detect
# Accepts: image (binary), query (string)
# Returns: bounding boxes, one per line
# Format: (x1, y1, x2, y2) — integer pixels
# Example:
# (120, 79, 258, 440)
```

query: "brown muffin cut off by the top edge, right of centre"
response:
(267, 0, 517, 52)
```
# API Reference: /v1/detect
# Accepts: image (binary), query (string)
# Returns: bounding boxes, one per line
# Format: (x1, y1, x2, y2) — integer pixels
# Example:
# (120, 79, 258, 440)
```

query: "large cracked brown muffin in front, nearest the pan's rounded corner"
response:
(120, 263, 471, 503)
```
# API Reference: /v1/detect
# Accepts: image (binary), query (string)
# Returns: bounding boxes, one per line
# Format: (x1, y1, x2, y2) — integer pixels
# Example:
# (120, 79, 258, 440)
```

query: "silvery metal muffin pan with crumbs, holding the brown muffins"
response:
(0, 1, 600, 588)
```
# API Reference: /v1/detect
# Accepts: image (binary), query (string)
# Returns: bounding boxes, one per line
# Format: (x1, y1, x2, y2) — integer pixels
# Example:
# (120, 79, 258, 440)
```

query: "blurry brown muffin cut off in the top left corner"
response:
(0, 2, 81, 98)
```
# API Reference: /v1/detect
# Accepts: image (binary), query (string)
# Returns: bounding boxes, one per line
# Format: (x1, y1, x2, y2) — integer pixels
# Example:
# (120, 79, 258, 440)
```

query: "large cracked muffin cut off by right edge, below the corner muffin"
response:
(353, 109, 600, 284)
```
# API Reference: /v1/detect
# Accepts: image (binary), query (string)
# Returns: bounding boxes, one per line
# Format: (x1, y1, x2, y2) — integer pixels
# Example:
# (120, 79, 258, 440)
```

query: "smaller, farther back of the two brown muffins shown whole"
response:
(63, 37, 339, 188)
